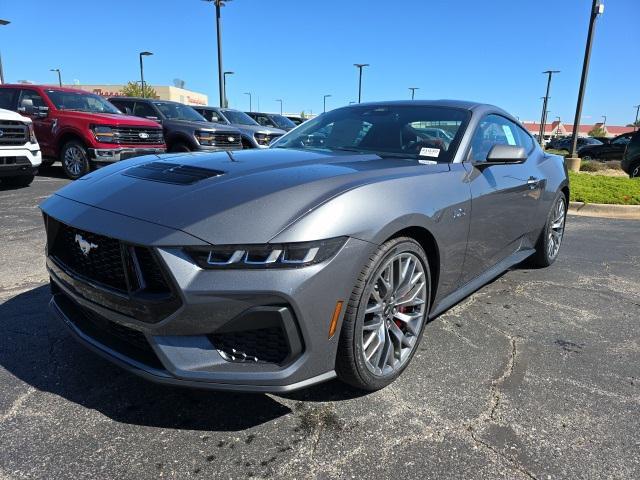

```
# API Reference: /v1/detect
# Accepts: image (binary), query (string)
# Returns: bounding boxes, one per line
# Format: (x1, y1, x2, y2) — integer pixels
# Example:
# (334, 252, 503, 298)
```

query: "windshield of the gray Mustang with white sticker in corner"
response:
(273, 105, 469, 162)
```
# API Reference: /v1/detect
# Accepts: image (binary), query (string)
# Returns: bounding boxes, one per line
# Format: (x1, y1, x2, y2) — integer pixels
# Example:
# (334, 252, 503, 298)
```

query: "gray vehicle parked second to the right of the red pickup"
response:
(193, 107, 286, 148)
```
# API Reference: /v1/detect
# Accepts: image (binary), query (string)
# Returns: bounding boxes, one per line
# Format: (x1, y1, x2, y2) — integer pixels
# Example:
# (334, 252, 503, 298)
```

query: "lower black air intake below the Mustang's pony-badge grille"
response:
(55, 293, 164, 370)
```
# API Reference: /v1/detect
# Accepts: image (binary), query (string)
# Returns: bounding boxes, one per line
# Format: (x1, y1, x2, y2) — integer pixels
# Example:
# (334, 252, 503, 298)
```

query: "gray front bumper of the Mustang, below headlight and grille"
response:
(47, 199, 375, 392)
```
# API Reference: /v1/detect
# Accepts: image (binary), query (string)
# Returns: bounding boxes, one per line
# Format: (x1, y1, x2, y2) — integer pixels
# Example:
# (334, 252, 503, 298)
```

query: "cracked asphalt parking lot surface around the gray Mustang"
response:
(0, 167, 640, 479)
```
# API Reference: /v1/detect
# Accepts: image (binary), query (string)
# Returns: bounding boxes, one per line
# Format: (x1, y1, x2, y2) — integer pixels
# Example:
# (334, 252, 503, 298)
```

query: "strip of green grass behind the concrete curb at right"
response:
(569, 172, 640, 205)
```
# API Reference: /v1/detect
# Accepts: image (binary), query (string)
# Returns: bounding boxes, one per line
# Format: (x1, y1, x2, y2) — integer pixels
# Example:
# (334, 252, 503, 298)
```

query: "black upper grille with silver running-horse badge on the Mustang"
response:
(47, 217, 171, 293)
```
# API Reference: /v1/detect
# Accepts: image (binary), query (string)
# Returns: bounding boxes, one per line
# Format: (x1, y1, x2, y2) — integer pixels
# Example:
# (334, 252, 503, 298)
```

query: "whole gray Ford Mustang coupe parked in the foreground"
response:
(42, 101, 569, 392)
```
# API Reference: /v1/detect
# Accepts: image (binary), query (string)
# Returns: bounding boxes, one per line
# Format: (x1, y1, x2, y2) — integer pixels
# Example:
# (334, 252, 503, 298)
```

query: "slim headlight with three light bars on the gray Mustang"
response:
(187, 237, 347, 269)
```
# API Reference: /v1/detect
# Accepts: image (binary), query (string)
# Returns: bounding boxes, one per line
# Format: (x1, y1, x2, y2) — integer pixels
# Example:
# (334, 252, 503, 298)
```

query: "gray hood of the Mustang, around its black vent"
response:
(43, 149, 428, 244)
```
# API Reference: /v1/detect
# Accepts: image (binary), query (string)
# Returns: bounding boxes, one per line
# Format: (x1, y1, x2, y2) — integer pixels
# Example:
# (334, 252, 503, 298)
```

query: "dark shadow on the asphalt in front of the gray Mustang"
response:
(0, 285, 291, 431)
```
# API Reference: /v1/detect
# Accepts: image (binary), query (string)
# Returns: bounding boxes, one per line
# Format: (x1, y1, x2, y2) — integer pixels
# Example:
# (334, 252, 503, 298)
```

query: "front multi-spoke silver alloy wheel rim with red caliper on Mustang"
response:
(361, 252, 427, 376)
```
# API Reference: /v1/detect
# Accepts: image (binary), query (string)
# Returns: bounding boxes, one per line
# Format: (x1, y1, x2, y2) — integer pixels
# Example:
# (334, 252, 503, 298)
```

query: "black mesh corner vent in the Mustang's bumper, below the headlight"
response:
(209, 326, 289, 364)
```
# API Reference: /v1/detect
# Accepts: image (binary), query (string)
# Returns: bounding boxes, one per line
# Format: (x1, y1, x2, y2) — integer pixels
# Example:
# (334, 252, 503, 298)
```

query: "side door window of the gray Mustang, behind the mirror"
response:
(470, 115, 533, 162)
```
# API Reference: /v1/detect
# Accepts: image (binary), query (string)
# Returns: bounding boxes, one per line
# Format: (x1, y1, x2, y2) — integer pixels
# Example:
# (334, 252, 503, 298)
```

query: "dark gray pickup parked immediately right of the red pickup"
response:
(109, 97, 242, 152)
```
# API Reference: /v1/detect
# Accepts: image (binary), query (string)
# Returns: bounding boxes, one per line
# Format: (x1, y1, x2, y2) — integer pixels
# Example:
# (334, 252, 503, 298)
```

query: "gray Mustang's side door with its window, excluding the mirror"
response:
(462, 114, 545, 283)
